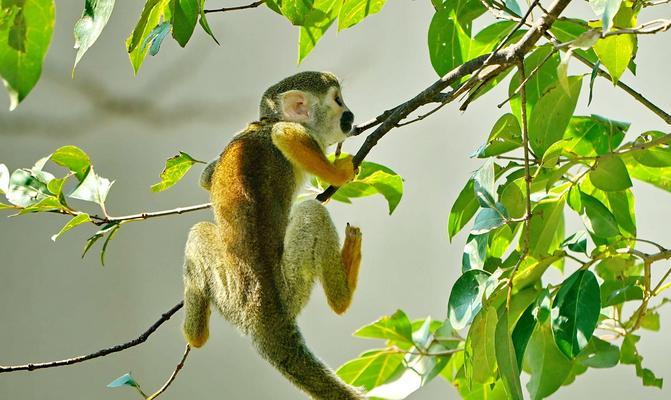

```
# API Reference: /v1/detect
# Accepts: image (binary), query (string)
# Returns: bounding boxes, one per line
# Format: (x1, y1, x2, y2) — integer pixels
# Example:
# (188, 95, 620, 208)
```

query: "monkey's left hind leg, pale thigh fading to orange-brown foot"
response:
(182, 222, 217, 347)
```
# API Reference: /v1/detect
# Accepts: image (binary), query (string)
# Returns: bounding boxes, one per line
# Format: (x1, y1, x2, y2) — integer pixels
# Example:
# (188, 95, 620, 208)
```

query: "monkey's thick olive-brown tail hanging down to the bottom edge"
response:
(254, 318, 365, 400)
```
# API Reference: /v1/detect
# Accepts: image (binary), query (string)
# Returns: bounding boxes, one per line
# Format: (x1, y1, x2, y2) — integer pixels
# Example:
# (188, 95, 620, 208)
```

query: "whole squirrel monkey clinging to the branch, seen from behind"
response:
(183, 72, 364, 400)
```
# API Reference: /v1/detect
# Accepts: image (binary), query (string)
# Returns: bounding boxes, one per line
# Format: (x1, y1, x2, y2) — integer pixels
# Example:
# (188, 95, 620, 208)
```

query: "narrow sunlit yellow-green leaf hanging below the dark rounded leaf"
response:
(464, 307, 498, 383)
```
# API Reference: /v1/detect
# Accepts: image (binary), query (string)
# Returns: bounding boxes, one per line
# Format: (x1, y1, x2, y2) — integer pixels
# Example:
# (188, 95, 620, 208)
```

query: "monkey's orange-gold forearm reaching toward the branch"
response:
(272, 122, 355, 186)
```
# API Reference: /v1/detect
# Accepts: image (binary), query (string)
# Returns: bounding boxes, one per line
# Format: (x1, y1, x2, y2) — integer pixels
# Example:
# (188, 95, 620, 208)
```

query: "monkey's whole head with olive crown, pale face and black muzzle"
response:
(260, 71, 354, 147)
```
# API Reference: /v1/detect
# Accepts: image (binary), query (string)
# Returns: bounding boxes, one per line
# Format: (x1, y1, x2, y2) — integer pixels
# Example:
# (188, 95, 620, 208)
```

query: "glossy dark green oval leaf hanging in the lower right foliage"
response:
(552, 270, 601, 358)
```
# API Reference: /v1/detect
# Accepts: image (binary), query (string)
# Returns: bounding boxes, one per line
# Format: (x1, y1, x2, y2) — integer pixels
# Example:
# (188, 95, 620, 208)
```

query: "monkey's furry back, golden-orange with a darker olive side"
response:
(211, 123, 296, 331)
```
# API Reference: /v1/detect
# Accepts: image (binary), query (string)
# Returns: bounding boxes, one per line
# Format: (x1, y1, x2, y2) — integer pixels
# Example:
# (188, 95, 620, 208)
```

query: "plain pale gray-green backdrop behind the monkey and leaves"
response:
(0, 1, 671, 400)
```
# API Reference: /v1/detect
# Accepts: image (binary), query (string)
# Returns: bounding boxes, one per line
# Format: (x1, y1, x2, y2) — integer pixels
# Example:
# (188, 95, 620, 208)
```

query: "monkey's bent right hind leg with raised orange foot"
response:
(282, 200, 361, 315)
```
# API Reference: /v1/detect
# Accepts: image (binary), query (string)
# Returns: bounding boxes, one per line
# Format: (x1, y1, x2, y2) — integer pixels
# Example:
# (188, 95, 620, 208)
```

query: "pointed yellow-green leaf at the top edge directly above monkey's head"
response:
(298, 0, 343, 63)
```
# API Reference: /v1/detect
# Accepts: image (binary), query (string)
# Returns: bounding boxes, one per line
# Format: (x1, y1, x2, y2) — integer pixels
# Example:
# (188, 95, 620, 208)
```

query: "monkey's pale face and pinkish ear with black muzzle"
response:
(282, 87, 354, 148)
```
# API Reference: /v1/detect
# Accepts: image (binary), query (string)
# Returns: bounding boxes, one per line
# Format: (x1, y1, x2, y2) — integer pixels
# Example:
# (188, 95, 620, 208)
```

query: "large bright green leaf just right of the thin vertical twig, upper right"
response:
(529, 76, 582, 157)
